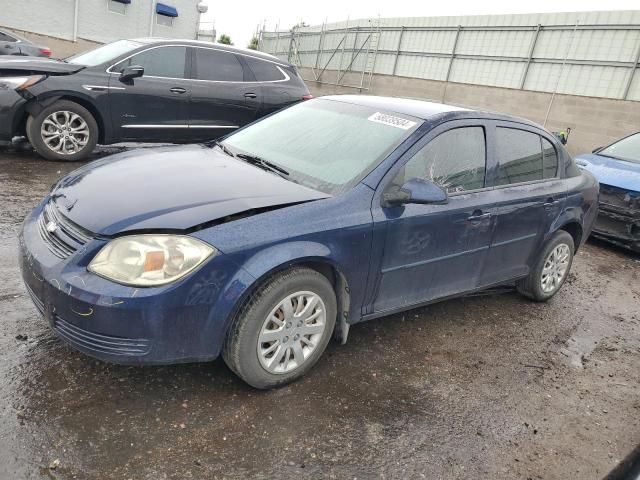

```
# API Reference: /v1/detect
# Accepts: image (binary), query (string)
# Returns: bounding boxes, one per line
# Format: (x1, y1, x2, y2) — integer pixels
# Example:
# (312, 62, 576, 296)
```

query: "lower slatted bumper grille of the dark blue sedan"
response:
(53, 315, 151, 357)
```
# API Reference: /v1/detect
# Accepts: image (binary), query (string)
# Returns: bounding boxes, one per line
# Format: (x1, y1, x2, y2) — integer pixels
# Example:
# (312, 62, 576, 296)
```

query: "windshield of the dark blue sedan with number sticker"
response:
(223, 99, 421, 195)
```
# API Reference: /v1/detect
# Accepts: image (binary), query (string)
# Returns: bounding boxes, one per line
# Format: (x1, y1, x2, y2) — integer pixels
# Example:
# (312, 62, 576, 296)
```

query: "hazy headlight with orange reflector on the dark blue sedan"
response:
(88, 235, 218, 287)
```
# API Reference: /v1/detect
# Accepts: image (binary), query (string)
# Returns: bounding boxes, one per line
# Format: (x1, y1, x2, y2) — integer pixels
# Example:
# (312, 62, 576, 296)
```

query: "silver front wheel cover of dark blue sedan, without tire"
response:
(257, 291, 327, 374)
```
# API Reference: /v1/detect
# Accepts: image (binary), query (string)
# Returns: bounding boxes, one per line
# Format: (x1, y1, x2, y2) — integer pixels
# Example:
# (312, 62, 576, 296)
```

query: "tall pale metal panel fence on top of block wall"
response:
(259, 11, 640, 101)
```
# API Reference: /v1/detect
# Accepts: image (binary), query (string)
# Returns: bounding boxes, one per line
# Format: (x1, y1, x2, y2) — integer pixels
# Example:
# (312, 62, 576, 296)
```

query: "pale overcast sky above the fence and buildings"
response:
(202, 0, 640, 47)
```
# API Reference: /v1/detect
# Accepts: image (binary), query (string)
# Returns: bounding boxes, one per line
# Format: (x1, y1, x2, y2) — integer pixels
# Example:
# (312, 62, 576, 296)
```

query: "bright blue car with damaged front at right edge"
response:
(576, 132, 640, 252)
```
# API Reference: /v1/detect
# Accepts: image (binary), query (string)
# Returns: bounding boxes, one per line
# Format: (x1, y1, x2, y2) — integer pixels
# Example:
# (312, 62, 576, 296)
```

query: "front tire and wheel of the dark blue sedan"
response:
(222, 267, 337, 389)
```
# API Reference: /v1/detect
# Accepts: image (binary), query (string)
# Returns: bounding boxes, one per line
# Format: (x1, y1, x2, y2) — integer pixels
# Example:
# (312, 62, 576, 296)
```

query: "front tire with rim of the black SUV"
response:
(26, 100, 98, 162)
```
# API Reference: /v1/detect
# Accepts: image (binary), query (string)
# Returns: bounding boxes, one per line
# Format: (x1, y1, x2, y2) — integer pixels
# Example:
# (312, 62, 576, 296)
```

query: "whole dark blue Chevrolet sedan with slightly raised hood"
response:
(20, 96, 598, 388)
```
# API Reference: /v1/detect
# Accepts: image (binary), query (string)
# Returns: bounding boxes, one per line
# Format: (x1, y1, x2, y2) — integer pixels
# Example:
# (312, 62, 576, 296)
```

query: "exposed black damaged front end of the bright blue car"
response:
(592, 184, 640, 252)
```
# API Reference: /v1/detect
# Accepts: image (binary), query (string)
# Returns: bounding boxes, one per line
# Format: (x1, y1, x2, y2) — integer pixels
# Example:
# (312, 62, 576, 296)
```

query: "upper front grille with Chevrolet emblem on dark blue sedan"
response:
(38, 201, 93, 259)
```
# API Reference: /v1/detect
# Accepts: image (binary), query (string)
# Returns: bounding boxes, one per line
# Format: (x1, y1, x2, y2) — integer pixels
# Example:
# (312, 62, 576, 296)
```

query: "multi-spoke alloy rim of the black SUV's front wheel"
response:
(40, 110, 89, 155)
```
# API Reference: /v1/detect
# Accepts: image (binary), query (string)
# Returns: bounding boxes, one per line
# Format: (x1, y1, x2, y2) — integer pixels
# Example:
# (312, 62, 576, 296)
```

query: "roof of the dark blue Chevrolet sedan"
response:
(320, 95, 541, 128)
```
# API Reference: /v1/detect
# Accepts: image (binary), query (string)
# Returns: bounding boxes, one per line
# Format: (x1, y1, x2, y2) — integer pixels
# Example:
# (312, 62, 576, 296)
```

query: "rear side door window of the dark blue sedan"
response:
(496, 127, 558, 185)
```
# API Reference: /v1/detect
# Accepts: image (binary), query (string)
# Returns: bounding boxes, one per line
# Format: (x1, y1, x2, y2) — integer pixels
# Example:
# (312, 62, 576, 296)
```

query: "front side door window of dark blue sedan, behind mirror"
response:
(392, 127, 486, 193)
